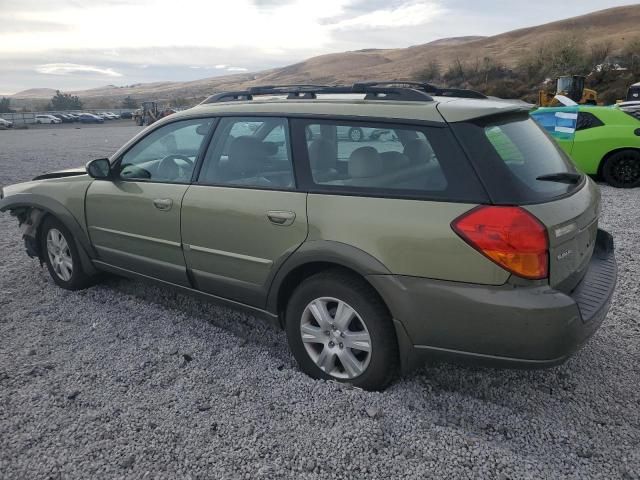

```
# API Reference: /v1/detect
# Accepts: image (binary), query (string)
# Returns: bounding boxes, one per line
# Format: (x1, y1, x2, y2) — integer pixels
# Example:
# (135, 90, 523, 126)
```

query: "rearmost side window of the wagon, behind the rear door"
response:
(294, 120, 486, 202)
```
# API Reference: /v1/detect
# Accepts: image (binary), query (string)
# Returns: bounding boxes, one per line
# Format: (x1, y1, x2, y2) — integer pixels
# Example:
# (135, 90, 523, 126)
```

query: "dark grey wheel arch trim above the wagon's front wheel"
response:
(0, 193, 97, 273)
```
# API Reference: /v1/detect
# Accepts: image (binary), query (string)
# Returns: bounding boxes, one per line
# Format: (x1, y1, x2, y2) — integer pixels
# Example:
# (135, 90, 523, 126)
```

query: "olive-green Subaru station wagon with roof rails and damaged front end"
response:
(0, 82, 616, 389)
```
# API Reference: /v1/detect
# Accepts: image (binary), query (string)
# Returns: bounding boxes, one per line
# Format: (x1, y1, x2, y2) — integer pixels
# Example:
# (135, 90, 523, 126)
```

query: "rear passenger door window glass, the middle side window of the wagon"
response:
(198, 117, 295, 189)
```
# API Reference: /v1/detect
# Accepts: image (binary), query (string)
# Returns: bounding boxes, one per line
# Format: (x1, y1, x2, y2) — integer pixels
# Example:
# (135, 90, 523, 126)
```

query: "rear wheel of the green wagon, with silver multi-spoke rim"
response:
(285, 270, 398, 390)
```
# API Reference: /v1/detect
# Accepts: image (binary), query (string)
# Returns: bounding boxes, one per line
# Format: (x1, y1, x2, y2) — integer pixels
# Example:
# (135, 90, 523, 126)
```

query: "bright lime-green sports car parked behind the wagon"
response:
(531, 102, 640, 188)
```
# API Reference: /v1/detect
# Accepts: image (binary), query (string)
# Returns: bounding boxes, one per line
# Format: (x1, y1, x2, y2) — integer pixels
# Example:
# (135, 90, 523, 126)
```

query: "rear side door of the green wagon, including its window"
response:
(182, 117, 307, 306)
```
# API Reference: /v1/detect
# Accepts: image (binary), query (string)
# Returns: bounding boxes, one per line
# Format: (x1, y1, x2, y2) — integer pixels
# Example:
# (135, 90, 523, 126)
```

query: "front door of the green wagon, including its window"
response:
(86, 119, 212, 286)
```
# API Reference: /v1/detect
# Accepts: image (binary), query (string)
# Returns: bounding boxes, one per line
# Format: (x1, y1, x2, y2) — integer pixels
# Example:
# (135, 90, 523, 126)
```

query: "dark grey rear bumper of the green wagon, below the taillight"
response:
(368, 230, 617, 371)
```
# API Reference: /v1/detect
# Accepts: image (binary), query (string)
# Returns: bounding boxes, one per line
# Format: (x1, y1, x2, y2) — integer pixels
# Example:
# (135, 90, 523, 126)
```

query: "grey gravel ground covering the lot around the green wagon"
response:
(0, 125, 640, 479)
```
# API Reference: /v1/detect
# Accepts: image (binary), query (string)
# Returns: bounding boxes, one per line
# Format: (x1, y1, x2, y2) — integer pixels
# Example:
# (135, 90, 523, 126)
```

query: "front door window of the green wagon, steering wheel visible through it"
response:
(118, 118, 213, 183)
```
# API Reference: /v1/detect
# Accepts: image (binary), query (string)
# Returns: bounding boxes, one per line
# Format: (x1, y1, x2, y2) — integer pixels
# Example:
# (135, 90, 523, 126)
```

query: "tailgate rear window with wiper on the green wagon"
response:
(452, 114, 582, 204)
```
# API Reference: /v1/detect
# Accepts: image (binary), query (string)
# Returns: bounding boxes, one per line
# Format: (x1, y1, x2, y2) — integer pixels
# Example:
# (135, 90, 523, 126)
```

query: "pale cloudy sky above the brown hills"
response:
(0, 0, 636, 95)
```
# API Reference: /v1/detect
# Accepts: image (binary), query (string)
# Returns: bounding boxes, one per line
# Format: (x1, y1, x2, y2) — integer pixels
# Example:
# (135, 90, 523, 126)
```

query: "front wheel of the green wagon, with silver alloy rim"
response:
(40, 216, 94, 290)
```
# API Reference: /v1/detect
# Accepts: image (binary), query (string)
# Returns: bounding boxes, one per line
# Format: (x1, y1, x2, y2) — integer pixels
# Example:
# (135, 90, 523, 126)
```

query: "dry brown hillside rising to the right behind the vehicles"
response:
(8, 4, 640, 104)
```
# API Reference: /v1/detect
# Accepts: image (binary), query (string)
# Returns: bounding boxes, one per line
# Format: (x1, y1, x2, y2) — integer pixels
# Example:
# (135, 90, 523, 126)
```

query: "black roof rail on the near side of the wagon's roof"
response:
(202, 82, 433, 104)
